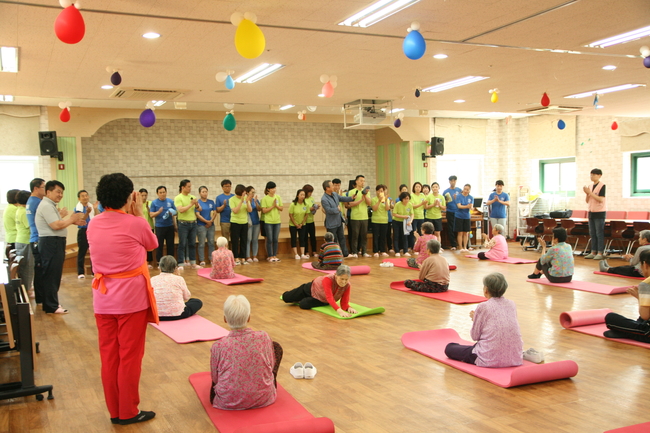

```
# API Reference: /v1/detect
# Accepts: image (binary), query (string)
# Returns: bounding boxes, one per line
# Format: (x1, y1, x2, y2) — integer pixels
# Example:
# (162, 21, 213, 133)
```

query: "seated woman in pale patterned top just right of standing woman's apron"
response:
(151, 256, 203, 321)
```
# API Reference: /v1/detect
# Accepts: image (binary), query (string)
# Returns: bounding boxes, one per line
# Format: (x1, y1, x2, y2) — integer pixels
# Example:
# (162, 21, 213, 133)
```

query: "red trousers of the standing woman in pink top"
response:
(95, 310, 148, 419)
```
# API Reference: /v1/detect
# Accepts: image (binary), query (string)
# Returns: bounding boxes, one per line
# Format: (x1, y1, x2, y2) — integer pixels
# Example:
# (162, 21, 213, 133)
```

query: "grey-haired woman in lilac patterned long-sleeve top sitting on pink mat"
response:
(445, 272, 523, 367)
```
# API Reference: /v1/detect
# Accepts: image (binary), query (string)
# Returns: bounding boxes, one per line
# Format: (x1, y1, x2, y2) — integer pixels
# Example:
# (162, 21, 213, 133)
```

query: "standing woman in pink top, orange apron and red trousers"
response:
(87, 173, 158, 425)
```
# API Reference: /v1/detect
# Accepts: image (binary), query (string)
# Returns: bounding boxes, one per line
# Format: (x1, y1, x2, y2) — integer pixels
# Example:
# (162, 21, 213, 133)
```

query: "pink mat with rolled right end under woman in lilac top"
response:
(402, 329, 578, 388)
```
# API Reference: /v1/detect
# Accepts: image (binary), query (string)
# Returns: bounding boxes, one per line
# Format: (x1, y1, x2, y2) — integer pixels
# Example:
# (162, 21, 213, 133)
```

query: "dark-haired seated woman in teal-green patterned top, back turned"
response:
(528, 227, 573, 283)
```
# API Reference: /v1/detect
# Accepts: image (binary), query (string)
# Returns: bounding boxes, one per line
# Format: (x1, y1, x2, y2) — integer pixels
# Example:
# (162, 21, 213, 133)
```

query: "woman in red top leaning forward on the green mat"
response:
(282, 265, 357, 317)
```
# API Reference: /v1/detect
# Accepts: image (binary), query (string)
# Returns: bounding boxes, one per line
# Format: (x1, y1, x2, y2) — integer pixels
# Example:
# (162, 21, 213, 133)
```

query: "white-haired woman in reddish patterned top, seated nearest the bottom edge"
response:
(210, 295, 282, 410)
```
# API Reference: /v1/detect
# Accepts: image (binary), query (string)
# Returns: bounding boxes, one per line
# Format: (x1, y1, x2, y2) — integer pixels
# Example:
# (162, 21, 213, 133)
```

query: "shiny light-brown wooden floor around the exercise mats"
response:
(0, 243, 650, 433)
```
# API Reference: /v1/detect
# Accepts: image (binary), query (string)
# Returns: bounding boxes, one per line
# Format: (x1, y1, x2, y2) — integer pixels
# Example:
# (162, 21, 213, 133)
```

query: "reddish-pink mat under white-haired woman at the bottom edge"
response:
(185, 371, 334, 433)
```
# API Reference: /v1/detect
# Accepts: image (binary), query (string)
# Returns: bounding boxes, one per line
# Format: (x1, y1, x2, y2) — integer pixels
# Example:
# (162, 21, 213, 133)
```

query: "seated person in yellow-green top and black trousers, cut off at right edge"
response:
(603, 250, 650, 343)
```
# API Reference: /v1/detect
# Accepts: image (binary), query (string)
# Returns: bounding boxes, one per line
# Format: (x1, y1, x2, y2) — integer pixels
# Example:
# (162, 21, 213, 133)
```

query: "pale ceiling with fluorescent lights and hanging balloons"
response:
(0, 0, 650, 117)
